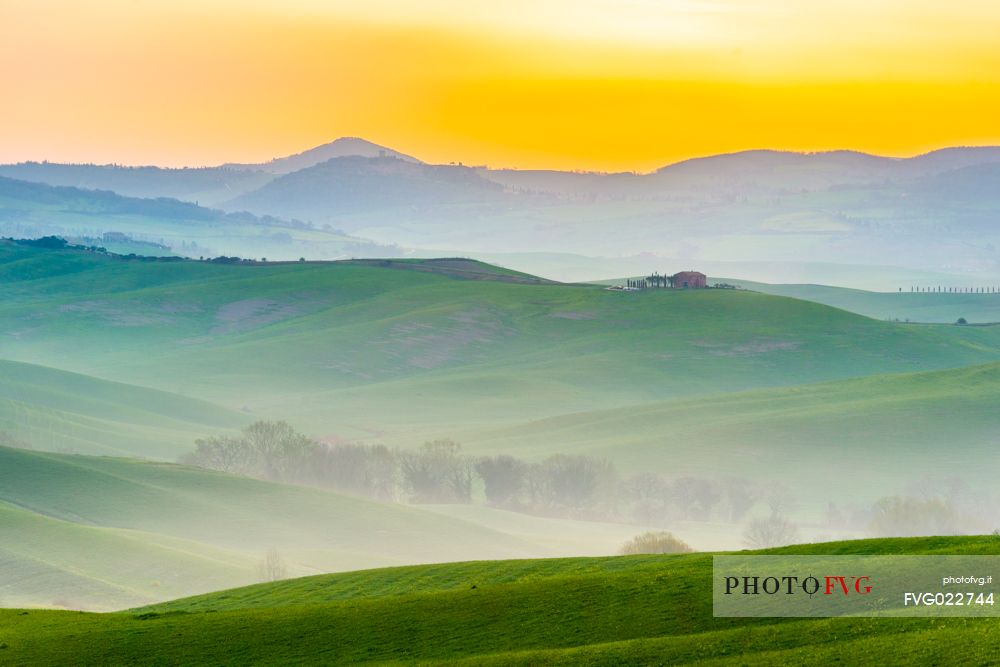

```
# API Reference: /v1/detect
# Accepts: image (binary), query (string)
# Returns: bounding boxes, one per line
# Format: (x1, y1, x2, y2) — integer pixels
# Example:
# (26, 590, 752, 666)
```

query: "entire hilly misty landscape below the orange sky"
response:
(0, 139, 1000, 664)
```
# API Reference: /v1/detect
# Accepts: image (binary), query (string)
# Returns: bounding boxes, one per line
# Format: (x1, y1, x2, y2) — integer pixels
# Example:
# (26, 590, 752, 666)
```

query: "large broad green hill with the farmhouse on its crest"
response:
(0, 243, 1000, 446)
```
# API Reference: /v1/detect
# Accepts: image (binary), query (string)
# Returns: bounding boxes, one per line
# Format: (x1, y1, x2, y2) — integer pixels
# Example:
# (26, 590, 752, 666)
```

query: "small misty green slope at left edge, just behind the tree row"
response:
(0, 360, 242, 459)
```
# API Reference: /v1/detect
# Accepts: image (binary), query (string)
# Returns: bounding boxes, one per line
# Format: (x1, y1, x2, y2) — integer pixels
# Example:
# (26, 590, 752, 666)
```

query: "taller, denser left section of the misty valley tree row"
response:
(182, 421, 617, 514)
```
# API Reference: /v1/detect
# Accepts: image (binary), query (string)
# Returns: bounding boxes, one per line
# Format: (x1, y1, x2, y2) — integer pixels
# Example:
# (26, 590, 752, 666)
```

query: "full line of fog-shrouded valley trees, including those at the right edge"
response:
(182, 421, 998, 547)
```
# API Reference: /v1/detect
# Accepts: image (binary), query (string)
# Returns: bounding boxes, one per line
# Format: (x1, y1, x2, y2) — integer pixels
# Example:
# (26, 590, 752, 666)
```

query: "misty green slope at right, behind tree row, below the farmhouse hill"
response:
(458, 364, 1000, 505)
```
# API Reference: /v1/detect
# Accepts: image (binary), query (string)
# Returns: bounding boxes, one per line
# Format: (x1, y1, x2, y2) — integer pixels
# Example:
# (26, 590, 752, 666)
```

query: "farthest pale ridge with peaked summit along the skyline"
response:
(7, 137, 1000, 205)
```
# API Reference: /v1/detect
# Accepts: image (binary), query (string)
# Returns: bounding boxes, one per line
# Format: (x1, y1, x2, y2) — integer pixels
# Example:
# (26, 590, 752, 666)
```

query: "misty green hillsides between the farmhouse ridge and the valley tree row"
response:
(0, 243, 1000, 524)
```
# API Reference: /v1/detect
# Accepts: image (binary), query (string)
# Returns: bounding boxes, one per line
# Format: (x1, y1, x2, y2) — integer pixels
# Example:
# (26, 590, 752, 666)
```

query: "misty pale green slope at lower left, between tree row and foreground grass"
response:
(0, 447, 552, 609)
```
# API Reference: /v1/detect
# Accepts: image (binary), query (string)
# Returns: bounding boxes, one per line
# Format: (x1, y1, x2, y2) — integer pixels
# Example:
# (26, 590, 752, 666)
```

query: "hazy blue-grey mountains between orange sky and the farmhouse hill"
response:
(0, 138, 1000, 280)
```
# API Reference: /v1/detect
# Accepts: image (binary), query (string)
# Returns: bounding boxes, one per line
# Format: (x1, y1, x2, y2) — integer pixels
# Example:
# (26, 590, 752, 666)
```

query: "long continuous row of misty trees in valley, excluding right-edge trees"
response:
(183, 421, 787, 525)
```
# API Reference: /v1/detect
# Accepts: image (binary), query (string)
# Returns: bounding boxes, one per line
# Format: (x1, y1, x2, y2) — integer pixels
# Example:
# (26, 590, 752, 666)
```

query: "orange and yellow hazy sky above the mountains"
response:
(0, 0, 1000, 170)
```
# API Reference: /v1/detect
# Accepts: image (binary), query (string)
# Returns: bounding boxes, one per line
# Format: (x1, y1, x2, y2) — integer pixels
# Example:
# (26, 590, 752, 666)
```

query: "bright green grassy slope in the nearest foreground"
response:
(0, 537, 1000, 664)
